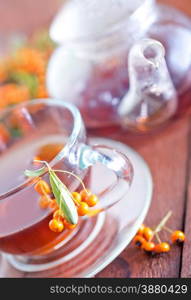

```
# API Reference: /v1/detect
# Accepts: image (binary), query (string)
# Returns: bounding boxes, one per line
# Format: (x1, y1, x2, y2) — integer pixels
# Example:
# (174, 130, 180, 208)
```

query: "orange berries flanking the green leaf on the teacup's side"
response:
(35, 179, 98, 232)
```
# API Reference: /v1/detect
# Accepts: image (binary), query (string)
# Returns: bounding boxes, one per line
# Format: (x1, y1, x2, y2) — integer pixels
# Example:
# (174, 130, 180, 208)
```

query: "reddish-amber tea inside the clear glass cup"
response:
(0, 136, 87, 255)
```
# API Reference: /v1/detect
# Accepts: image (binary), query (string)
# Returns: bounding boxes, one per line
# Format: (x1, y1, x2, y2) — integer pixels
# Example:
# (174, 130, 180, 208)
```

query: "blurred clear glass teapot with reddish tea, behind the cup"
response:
(47, 0, 191, 131)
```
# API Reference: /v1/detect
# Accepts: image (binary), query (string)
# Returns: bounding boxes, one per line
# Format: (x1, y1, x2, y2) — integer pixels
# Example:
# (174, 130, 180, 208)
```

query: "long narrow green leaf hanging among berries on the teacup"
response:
(49, 170, 78, 224)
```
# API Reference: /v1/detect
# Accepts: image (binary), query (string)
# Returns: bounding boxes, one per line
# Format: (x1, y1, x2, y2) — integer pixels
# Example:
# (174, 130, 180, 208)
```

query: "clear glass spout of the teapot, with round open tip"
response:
(118, 39, 177, 131)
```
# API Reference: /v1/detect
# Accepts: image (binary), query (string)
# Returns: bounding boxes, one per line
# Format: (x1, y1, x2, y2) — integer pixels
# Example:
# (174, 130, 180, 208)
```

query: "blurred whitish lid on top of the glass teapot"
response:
(50, 0, 148, 43)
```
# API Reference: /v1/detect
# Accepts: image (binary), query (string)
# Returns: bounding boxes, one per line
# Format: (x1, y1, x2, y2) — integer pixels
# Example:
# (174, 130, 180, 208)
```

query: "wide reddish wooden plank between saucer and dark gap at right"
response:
(97, 117, 189, 277)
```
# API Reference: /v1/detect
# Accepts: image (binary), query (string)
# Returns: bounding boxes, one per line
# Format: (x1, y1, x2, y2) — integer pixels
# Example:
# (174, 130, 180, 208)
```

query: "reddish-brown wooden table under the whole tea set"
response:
(0, 0, 191, 278)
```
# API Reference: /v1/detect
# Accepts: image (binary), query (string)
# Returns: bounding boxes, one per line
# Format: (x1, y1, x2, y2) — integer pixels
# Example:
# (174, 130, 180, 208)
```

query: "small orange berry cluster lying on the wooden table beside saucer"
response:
(133, 225, 185, 255)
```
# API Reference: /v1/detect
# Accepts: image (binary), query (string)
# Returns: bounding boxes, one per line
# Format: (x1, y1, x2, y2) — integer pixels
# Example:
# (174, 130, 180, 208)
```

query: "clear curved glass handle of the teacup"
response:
(78, 144, 133, 209)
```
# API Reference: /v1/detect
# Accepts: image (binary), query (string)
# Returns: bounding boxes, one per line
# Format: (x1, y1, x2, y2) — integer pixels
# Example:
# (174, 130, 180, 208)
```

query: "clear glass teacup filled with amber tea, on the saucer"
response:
(0, 99, 133, 271)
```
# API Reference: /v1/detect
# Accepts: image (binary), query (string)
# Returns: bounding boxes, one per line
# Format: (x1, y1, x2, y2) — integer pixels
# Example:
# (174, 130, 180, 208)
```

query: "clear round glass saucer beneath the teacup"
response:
(0, 138, 153, 278)
